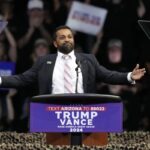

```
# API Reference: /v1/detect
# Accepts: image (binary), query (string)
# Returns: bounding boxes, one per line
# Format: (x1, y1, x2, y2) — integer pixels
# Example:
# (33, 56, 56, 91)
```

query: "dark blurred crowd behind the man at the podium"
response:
(0, 0, 150, 132)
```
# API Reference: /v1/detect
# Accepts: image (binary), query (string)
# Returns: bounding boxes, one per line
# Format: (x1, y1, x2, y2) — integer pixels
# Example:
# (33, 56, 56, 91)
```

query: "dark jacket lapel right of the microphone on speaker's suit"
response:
(75, 53, 88, 93)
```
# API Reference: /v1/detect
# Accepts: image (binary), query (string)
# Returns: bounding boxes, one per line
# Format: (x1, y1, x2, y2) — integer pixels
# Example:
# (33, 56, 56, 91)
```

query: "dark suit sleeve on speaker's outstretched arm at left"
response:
(0, 59, 42, 88)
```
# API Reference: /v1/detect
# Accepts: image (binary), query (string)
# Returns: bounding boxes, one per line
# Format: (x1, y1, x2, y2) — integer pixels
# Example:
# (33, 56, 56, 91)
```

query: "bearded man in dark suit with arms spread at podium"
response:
(0, 26, 146, 94)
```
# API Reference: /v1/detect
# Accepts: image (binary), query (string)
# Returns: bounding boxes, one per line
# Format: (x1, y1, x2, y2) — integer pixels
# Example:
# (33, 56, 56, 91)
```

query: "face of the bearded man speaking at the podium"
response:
(54, 29, 74, 54)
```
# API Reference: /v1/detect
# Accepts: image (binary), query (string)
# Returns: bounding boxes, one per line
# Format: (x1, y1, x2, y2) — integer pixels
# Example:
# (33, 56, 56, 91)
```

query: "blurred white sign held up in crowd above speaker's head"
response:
(66, 1, 107, 35)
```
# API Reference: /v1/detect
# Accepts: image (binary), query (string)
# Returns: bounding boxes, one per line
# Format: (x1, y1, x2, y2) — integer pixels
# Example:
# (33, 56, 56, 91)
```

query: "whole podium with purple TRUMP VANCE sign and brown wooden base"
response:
(30, 94, 123, 146)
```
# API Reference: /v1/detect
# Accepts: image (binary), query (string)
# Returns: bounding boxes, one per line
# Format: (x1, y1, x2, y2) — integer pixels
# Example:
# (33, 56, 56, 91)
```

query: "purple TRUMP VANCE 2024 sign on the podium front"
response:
(30, 103, 123, 132)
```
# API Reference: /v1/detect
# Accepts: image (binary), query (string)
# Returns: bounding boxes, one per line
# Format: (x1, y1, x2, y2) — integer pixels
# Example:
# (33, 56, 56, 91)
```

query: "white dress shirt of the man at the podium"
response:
(52, 51, 84, 94)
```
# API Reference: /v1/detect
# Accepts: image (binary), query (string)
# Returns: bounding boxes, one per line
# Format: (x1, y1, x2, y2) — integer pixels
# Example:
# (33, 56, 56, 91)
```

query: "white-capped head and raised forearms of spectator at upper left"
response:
(18, 0, 51, 48)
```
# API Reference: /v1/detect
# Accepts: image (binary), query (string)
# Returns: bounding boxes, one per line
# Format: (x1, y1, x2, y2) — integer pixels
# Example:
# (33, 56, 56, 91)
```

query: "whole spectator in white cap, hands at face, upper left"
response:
(17, 0, 51, 72)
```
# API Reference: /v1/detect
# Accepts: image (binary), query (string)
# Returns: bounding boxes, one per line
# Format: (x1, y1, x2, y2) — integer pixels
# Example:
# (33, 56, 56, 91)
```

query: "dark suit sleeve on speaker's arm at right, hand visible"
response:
(92, 55, 129, 84)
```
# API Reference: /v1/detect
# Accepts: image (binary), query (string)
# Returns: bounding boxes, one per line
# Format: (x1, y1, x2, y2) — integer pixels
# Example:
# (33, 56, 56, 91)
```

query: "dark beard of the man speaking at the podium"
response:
(58, 43, 74, 54)
